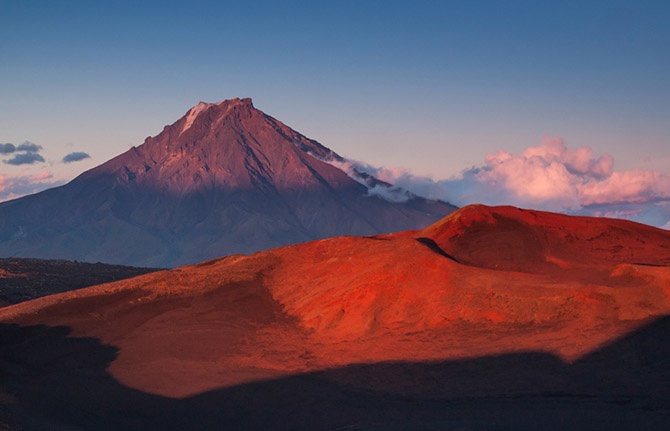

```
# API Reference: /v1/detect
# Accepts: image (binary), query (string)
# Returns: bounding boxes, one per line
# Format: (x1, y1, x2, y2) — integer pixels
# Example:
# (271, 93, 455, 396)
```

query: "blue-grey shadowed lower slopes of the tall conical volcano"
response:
(0, 187, 455, 268)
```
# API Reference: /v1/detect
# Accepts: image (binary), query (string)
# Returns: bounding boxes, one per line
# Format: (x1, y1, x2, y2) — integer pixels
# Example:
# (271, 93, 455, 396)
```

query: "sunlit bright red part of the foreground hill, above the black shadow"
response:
(0, 206, 670, 397)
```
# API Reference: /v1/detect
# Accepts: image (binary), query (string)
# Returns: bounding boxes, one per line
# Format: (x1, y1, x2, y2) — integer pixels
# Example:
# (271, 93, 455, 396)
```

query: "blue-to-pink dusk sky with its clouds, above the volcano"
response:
(0, 0, 670, 228)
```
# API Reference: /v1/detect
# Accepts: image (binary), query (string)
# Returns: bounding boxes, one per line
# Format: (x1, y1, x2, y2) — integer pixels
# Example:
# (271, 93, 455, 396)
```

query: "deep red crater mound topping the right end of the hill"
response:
(422, 205, 670, 272)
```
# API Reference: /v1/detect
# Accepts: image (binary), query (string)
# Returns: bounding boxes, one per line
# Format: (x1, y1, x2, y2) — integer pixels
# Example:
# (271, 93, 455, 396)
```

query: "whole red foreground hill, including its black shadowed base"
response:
(0, 205, 670, 430)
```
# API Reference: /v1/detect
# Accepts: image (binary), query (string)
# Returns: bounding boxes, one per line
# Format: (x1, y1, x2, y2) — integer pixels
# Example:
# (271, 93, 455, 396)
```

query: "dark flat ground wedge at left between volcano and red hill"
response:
(0, 258, 158, 307)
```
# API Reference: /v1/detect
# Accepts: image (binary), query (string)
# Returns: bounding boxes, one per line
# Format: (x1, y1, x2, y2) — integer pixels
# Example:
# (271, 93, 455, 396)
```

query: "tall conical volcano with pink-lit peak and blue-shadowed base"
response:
(0, 99, 455, 267)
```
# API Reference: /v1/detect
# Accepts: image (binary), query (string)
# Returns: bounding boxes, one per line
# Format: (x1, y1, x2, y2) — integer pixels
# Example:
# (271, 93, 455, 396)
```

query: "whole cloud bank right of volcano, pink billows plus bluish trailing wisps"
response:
(322, 137, 670, 227)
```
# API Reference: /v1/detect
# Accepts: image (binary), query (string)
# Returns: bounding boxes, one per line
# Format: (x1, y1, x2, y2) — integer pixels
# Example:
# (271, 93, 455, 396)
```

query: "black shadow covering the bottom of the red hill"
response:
(0, 317, 670, 430)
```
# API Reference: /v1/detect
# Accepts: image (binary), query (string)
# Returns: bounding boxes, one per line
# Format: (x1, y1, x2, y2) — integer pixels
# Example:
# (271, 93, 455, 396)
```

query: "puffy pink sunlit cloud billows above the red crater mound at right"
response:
(476, 137, 670, 211)
